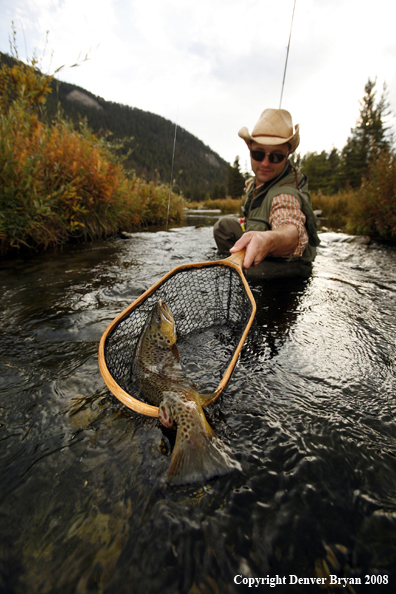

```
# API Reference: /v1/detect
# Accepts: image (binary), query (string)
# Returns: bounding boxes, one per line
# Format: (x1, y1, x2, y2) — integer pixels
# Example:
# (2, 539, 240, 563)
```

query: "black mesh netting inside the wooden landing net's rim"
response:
(104, 264, 253, 394)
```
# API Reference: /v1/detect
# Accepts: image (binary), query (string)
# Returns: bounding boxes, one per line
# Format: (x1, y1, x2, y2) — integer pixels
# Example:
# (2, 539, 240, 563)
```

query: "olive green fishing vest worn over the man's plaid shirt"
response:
(242, 163, 320, 262)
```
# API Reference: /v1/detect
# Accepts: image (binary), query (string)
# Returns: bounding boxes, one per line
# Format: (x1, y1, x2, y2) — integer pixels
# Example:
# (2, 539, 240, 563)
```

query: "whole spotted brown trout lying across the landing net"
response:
(132, 300, 240, 485)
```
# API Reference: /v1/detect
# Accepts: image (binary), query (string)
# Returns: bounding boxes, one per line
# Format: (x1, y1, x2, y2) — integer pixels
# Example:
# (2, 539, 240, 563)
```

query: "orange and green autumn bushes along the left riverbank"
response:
(0, 52, 184, 255)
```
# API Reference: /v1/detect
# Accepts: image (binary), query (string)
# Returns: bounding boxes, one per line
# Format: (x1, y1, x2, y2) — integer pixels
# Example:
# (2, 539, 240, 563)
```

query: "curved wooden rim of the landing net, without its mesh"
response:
(98, 249, 256, 417)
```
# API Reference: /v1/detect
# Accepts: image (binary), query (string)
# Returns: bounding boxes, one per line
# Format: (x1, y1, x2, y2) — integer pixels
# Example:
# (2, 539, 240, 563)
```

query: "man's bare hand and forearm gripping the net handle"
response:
(230, 224, 298, 268)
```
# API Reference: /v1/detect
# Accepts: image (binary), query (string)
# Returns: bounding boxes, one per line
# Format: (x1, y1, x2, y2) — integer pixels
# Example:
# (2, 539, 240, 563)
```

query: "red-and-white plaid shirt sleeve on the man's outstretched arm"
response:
(269, 194, 308, 257)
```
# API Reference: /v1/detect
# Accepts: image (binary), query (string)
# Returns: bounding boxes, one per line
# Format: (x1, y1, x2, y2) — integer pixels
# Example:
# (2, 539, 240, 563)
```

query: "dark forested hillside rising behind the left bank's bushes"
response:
(0, 52, 227, 199)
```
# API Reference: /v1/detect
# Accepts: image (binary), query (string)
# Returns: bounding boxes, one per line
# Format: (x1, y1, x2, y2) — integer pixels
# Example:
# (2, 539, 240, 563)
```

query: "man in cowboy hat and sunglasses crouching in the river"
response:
(213, 109, 319, 276)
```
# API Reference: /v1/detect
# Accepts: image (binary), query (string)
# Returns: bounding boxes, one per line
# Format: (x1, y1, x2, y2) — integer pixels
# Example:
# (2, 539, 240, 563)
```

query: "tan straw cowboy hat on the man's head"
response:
(238, 109, 300, 153)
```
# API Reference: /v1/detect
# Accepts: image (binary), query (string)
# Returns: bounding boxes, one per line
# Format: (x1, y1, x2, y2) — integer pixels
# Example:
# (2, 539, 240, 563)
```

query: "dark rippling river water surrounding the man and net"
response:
(0, 218, 396, 594)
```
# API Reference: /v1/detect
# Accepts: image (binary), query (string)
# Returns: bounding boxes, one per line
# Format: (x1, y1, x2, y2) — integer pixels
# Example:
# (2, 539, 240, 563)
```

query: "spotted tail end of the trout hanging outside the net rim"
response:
(168, 394, 241, 485)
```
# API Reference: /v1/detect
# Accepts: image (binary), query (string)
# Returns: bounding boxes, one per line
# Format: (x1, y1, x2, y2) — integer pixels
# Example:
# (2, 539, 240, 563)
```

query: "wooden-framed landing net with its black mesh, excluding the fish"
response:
(99, 250, 256, 417)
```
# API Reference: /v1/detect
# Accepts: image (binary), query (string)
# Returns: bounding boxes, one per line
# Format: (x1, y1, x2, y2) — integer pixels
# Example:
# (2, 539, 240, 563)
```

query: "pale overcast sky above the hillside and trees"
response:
(0, 0, 396, 168)
